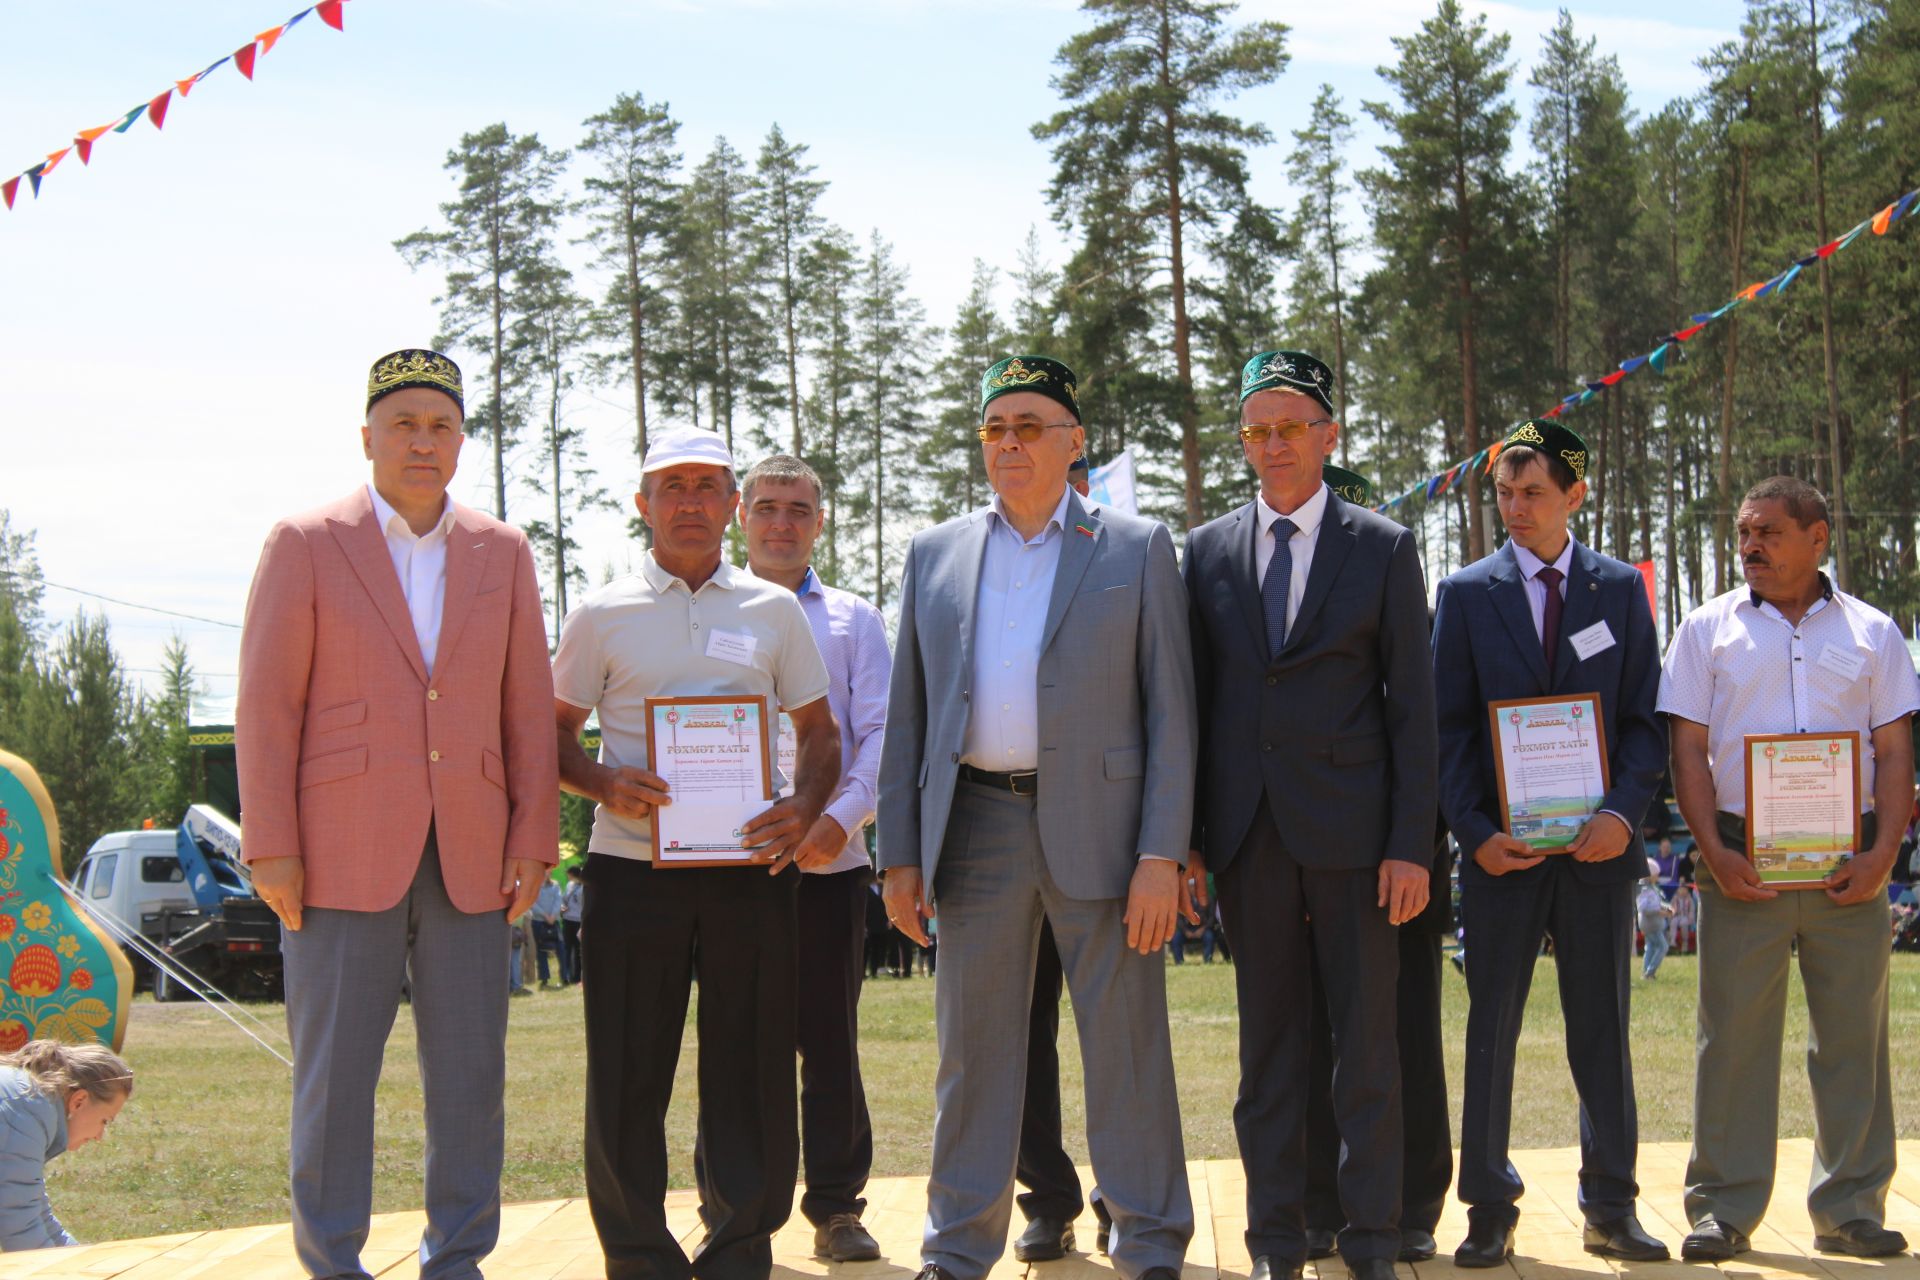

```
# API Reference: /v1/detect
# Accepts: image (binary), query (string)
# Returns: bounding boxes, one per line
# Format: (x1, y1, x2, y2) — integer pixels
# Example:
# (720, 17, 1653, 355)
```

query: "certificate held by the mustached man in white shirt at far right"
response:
(1745, 729, 1860, 889)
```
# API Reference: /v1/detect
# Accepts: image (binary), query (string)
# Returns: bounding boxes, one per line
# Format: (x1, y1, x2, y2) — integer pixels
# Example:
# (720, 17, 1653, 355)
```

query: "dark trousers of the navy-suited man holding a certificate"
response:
(1459, 852, 1640, 1226)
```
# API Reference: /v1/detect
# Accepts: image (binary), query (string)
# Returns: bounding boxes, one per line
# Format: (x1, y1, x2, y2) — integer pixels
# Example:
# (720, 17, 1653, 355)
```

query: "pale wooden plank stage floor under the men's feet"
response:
(0, 1140, 1920, 1280)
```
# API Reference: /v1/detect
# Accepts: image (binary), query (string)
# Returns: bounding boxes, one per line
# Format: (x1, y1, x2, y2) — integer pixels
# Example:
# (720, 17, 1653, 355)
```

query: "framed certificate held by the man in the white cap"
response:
(647, 695, 774, 867)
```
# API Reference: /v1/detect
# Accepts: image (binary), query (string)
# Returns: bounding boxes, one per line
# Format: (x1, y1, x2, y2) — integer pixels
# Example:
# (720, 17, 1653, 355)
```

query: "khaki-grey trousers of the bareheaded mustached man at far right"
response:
(1686, 877, 1895, 1234)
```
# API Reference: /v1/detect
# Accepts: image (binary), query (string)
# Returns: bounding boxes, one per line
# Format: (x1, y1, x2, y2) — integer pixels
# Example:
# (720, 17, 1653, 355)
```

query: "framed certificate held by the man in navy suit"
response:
(1486, 693, 1607, 854)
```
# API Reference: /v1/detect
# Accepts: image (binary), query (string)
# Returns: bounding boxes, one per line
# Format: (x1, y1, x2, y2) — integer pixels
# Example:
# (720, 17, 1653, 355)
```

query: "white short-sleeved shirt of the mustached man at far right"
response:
(1655, 574, 1920, 821)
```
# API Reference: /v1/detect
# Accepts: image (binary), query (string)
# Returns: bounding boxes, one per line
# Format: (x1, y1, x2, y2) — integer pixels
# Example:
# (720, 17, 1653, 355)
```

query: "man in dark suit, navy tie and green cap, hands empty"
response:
(1183, 351, 1436, 1280)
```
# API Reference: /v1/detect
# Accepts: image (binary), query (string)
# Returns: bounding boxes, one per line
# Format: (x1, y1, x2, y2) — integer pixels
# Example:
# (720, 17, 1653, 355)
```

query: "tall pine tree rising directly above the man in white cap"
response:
(580, 94, 680, 472)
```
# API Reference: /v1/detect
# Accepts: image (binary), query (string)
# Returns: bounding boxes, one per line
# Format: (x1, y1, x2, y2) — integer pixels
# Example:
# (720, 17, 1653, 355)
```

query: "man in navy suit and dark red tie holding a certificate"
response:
(1432, 420, 1667, 1267)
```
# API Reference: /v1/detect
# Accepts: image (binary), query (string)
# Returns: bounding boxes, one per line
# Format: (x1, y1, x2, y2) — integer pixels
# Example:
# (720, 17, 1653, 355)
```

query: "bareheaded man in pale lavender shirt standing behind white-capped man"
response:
(739, 455, 893, 1263)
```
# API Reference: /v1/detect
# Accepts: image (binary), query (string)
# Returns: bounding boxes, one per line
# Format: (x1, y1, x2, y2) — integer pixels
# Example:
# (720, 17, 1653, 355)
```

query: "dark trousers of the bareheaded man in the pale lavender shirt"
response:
(799, 867, 874, 1226)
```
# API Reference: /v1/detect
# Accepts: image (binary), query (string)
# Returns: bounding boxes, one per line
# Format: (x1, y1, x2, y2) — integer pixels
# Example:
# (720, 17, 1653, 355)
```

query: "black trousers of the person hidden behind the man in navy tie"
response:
(1308, 921, 1453, 1234)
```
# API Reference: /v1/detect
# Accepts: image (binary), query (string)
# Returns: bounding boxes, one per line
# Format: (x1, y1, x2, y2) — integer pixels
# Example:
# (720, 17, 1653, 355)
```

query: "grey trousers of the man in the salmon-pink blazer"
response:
(280, 833, 507, 1280)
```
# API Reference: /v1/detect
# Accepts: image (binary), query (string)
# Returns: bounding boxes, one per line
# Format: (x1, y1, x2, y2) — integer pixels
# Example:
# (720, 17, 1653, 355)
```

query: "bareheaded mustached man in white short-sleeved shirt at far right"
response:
(1659, 476, 1920, 1263)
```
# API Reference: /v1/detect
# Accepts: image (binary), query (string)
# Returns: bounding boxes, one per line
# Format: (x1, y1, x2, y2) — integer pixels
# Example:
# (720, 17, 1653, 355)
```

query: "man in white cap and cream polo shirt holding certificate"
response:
(553, 430, 841, 1280)
